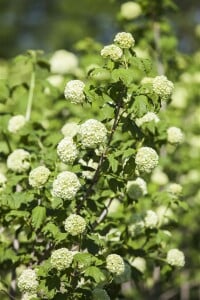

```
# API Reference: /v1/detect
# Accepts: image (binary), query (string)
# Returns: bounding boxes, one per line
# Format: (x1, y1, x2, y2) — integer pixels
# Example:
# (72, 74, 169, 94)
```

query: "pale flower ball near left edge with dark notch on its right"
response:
(7, 149, 31, 173)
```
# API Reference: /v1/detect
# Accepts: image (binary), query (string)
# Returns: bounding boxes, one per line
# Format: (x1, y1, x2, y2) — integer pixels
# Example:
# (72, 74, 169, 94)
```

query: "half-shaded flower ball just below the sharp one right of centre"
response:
(126, 177, 147, 199)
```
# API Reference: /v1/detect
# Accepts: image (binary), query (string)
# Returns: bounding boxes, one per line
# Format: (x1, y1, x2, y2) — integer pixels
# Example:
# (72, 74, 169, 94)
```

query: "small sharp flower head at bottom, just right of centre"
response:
(106, 254, 125, 275)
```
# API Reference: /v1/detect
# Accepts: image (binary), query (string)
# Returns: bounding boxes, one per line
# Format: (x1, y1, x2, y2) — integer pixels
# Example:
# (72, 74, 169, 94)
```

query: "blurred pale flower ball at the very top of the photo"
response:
(120, 1, 142, 20)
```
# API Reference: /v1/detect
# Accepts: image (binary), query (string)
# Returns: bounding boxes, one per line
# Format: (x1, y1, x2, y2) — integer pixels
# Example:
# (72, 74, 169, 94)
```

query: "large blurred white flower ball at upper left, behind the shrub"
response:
(50, 50, 78, 74)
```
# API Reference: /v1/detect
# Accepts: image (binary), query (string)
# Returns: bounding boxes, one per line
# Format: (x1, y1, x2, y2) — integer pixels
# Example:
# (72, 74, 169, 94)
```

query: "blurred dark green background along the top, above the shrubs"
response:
(0, 0, 200, 58)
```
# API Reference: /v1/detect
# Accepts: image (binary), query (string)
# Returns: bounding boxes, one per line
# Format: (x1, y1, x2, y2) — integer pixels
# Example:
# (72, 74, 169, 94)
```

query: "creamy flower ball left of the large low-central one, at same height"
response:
(28, 166, 50, 188)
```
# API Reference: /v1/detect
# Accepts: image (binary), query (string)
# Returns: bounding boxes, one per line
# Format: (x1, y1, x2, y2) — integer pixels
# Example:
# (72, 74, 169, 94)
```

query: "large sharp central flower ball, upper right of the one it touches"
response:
(79, 119, 107, 148)
